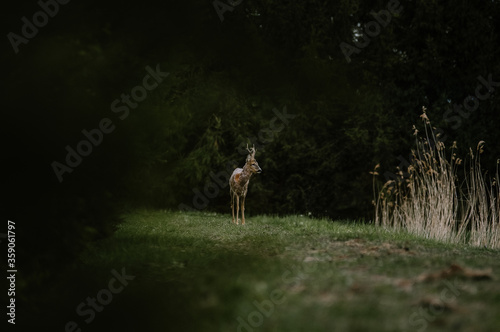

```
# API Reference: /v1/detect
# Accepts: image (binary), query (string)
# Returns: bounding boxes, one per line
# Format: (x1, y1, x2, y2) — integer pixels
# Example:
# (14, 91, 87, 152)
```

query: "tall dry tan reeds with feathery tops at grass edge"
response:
(372, 108, 500, 248)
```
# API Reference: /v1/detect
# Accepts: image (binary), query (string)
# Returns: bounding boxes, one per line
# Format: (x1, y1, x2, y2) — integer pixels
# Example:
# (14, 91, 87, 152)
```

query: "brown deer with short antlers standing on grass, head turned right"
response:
(229, 144, 262, 225)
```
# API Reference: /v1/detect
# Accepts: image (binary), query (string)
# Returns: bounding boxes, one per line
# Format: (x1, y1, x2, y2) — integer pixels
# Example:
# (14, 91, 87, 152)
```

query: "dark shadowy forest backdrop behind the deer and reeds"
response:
(1, 0, 500, 320)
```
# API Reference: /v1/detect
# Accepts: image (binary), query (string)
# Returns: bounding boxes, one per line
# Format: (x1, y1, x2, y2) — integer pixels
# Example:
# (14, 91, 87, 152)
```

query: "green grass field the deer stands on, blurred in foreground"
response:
(23, 210, 500, 332)
